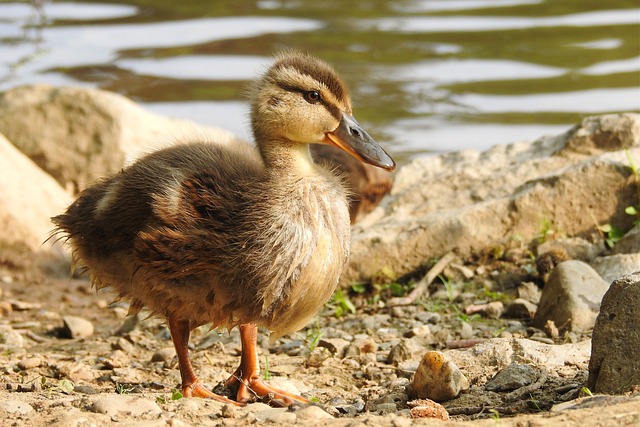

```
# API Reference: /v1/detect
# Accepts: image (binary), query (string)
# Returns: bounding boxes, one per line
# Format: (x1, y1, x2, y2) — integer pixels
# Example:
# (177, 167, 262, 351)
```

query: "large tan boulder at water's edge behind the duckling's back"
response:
(0, 85, 233, 191)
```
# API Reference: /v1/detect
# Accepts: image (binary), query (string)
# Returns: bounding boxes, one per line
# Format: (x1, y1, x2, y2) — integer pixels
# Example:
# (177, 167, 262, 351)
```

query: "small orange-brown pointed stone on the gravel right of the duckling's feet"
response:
(407, 351, 469, 402)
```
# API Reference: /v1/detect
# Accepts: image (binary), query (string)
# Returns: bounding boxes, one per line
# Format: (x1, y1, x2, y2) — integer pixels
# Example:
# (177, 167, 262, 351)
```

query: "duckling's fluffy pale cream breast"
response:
(249, 172, 350, 339)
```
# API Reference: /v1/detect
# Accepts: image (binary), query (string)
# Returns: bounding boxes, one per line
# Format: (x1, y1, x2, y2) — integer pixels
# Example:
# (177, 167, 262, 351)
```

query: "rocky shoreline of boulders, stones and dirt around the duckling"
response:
(0, 86, 640, 426)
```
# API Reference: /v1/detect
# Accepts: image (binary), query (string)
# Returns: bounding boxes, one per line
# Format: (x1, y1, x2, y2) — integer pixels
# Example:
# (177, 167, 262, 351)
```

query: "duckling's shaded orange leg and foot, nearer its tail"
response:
(169, 318, 244, 406)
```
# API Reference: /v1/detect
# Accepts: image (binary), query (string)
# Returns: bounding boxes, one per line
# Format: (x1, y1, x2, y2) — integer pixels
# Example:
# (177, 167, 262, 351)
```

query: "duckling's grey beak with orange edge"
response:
(324, 113, 396, 171)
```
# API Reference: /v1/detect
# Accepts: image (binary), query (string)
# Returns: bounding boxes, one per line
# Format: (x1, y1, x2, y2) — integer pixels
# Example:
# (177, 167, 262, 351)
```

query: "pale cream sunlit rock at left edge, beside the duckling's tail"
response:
(0, 132, 71, 253)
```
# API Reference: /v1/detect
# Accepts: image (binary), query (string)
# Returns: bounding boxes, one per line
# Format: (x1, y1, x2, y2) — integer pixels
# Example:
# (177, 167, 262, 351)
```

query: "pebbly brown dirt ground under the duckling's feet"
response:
(0, 248, 640, 427)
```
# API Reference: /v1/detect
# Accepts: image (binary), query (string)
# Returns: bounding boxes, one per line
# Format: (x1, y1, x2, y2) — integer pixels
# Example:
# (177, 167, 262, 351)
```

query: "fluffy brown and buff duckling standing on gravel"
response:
(52, 52, 395, 406)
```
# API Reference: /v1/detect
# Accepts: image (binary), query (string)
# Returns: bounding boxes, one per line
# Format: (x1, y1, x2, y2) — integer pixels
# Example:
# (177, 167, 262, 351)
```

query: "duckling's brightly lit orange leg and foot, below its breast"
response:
(225, 323, 309, 406)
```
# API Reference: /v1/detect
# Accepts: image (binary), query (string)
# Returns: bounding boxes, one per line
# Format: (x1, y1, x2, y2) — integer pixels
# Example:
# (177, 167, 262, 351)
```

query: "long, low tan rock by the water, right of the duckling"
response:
(342, 113, 640, 285)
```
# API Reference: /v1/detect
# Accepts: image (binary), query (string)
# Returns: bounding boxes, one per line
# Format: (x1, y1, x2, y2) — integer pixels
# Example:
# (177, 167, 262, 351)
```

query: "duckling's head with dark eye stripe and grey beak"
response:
(251, 52, 395, 170)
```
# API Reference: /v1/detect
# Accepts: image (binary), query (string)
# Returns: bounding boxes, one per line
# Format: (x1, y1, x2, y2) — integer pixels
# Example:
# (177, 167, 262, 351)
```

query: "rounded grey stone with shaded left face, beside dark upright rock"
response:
(533, 260, 609, 332)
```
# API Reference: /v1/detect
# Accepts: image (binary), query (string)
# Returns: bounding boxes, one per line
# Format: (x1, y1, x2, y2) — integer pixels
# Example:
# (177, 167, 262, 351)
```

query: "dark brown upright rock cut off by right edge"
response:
(588, 271, 640, 394)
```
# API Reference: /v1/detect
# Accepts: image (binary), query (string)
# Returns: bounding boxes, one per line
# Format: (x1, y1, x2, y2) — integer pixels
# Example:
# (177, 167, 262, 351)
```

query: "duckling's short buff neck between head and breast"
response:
(258, 140, 316, 177)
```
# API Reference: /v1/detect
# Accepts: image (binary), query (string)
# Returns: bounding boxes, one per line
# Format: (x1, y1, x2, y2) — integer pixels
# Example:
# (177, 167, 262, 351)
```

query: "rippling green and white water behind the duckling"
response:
(0, 0, 640, 162)
